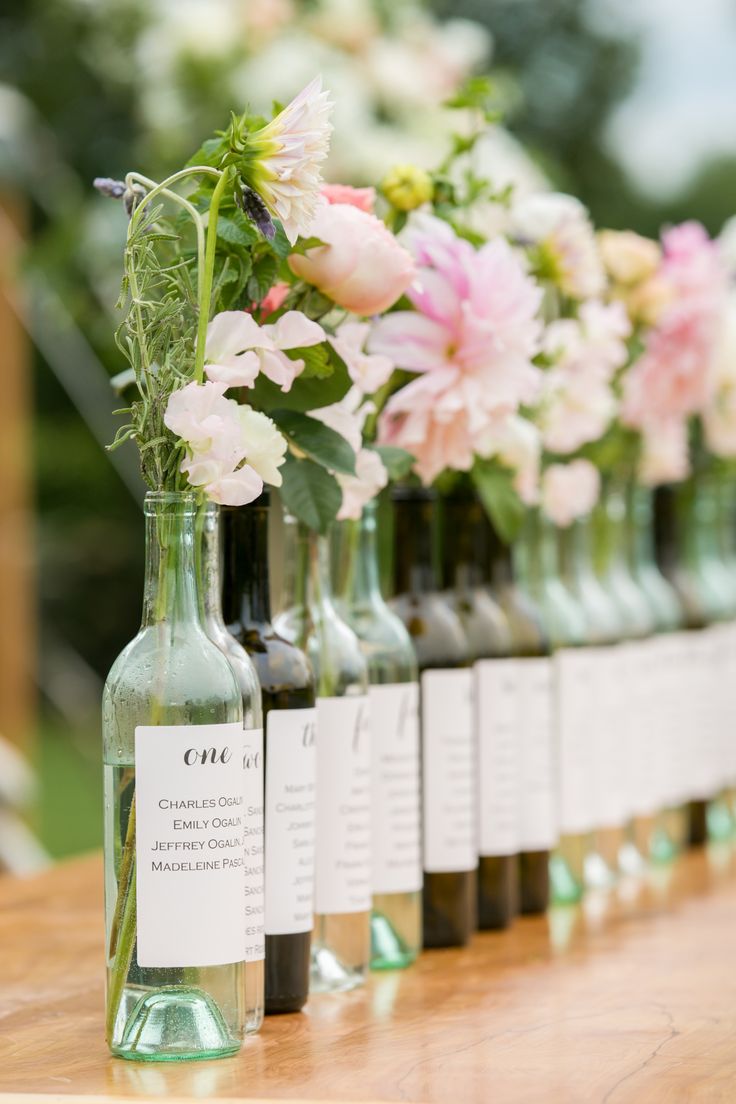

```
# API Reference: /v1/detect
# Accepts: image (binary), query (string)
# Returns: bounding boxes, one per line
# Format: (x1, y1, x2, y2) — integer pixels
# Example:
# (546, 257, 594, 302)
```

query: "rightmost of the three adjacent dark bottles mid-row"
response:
(487, 520, 556, 915)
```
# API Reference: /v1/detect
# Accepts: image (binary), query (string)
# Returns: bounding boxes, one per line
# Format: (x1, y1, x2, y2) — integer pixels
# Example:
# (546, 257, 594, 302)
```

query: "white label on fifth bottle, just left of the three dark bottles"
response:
(369, 682, 422, 893)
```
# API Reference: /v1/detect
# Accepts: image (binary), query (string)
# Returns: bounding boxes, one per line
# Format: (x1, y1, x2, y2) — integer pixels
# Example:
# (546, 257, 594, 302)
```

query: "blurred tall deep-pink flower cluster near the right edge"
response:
(623, 222, 726, 429)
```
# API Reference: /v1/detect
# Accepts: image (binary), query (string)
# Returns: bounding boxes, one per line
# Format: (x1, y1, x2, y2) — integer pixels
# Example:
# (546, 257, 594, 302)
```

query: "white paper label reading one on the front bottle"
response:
(136, 723, 246, 967)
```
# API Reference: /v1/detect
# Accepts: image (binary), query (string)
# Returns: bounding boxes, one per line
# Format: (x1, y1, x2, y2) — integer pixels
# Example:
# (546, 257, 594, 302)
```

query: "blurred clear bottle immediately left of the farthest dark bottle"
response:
(627, 480, 687, 863)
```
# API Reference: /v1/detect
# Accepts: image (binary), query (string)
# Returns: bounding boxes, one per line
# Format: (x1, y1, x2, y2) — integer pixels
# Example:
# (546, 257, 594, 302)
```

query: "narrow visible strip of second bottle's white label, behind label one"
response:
(243, 729, 266, 963)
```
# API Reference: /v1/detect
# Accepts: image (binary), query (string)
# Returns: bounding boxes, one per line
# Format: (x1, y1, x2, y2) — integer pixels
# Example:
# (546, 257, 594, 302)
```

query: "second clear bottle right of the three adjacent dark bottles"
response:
(557, 517, 626, 890)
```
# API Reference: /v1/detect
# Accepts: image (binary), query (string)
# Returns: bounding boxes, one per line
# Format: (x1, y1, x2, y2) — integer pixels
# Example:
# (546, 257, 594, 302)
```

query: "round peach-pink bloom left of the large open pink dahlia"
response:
(289, 203, 415, 316)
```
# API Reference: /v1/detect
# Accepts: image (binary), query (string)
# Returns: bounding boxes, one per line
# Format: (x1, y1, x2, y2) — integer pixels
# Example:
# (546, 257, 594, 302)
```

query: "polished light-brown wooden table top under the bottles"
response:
(0, 852, 736, 1104)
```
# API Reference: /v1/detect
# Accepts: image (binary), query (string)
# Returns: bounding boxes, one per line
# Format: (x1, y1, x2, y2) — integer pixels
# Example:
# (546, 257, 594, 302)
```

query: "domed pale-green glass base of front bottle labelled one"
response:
(110, 986, 242, 1062)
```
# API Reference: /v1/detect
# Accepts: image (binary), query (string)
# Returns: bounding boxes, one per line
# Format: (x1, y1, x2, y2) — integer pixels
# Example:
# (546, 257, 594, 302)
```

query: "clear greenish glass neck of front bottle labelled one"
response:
(141, 491, 202, 628)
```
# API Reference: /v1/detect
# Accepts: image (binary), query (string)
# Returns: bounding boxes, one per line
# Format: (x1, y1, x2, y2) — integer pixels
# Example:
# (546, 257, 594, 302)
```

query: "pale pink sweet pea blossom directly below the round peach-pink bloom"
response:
(204, 310, 327, 392)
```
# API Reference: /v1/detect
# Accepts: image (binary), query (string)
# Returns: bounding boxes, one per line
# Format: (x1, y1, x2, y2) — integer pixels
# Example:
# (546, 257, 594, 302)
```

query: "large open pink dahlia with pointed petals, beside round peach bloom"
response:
(369, 214, 542, 481)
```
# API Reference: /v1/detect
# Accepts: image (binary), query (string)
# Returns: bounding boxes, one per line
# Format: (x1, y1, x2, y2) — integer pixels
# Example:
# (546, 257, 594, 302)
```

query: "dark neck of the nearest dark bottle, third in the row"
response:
(222, 503, 270, 627)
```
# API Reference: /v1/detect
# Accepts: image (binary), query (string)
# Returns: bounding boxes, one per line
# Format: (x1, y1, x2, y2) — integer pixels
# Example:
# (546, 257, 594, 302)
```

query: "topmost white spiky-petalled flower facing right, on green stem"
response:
(241, 76, 332, 245)
